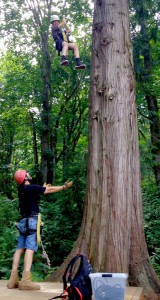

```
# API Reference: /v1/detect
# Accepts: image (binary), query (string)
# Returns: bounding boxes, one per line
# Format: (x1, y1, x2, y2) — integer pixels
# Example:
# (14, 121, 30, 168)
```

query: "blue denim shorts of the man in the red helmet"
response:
(17, 217, 38, 251)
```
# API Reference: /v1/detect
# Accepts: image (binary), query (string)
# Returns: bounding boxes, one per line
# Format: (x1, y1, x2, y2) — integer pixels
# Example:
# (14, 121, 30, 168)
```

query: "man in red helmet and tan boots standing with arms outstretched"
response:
(7, 170, 72, 290)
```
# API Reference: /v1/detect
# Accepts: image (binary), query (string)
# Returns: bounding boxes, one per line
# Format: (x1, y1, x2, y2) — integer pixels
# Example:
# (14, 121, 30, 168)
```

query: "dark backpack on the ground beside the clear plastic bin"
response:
(49, 254, 93, 300)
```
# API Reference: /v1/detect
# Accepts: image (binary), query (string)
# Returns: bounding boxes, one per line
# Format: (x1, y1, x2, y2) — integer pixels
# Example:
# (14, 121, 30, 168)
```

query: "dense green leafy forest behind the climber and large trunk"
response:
(0, 0, 160, 280)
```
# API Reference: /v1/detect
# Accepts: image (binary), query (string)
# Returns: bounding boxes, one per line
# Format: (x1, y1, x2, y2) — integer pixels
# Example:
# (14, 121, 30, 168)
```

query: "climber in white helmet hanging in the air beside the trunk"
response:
(51, 15, 86, 69)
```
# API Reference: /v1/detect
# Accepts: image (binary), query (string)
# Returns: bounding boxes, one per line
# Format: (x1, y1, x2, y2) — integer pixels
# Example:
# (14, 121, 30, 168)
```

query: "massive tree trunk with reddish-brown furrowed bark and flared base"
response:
(47, 0, 159, 299)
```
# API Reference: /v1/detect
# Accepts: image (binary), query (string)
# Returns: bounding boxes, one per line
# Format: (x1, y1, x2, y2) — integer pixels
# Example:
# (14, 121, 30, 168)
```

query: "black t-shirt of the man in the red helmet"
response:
(18, 184, 46, 217)
